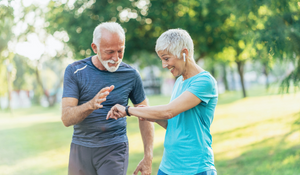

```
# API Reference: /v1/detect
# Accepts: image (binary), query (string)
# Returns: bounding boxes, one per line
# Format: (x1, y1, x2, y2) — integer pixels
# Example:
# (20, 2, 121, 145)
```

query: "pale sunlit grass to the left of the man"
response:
(0, 106, 72, 175)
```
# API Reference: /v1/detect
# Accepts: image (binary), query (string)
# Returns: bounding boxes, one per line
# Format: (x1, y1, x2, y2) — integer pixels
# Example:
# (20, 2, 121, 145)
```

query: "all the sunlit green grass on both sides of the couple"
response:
(0, 87, 300, 175)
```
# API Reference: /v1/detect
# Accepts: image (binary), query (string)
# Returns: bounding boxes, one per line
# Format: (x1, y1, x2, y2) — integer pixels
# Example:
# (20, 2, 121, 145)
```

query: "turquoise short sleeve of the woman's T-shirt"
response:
(187, 76, 217, 105)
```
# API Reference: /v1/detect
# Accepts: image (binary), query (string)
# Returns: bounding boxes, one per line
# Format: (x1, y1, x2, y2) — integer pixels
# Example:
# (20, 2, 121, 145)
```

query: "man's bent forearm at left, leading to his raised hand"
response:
(61, 103, 94, 127)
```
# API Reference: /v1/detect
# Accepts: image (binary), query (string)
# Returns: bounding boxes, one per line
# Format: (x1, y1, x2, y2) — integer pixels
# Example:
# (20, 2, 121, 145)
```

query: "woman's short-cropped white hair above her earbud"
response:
(155, 29, 194, 60)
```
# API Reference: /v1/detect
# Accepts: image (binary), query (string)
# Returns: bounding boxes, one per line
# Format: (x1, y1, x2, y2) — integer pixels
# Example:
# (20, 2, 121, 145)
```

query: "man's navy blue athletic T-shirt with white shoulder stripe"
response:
(63, 57, 146, 147)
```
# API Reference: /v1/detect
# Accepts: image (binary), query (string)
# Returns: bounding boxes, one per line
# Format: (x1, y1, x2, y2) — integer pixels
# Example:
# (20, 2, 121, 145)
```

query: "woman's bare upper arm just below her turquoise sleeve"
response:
(167, 91, 201, 116)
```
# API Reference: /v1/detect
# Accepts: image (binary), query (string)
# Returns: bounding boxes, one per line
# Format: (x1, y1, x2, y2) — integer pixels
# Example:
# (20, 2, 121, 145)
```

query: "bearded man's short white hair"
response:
(93, 22, 125, 49)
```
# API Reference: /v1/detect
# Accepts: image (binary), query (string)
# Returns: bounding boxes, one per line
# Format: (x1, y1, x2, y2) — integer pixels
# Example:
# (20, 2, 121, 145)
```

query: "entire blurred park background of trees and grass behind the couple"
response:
(0, 0, 300, 175)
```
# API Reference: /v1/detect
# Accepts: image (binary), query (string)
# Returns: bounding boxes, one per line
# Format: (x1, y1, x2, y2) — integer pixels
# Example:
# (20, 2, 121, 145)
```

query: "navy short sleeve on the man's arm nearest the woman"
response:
(129, 71, 146, 104)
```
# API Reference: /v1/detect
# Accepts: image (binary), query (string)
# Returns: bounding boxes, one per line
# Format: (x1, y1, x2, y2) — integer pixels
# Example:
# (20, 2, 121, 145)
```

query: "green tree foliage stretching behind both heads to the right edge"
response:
(46, 0, 300, 97)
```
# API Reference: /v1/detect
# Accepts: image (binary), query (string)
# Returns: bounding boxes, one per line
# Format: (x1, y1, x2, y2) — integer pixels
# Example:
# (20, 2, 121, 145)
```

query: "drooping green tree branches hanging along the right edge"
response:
(255, 0, 300, 92)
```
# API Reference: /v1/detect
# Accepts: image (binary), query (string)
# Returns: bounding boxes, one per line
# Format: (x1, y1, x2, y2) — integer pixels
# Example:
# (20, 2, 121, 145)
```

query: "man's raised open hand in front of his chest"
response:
(89, 85, 115, 110)
